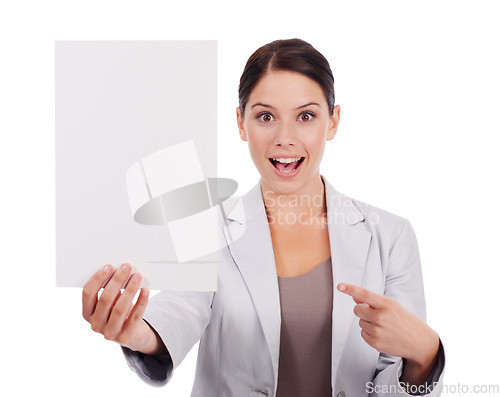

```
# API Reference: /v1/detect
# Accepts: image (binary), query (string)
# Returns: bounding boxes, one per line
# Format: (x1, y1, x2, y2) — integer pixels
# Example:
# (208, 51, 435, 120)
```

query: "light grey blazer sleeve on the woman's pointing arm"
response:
(369, 219, 445, 397)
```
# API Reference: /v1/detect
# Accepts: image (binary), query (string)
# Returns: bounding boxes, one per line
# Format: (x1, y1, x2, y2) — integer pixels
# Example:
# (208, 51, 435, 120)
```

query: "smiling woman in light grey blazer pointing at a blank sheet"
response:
(83, 39, 444, 397)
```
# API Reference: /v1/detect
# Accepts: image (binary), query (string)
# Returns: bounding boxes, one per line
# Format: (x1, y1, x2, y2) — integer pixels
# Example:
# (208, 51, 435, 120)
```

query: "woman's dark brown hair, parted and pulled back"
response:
(238, 39, 335, 116)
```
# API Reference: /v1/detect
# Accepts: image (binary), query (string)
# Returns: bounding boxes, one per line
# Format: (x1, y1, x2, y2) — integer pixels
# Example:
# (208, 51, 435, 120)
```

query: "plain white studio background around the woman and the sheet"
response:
(0, 1, 500, 397)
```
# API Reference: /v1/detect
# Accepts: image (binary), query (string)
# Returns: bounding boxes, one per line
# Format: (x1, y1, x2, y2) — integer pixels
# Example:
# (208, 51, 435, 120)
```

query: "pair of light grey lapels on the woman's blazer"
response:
(226, 175, 371, 386)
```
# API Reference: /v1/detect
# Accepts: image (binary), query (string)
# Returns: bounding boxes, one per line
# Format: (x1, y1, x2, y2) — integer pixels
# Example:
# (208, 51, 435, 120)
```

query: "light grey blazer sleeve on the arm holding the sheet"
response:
(122, 291, 215, 386)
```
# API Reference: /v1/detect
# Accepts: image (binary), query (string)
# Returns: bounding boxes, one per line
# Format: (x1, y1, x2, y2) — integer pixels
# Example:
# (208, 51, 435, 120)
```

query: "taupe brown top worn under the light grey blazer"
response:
(276, 258, 333, 397)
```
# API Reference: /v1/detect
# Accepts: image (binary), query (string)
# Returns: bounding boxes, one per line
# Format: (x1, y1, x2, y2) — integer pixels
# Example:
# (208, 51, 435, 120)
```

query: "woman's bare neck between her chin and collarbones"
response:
(261, 172, 326, 216)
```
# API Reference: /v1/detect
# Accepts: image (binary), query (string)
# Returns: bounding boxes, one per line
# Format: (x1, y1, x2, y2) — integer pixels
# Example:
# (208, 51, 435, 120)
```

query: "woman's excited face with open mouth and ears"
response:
(237, 71, 340, 194)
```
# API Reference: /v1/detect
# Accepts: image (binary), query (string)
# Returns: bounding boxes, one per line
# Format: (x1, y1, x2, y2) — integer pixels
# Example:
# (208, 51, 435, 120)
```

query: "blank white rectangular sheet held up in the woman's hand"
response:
(55, 41, 225, 290)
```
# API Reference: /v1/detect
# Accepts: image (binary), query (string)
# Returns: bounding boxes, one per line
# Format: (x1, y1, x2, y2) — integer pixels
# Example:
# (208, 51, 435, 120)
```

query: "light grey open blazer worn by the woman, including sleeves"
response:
(123, 176, 444, 397)
